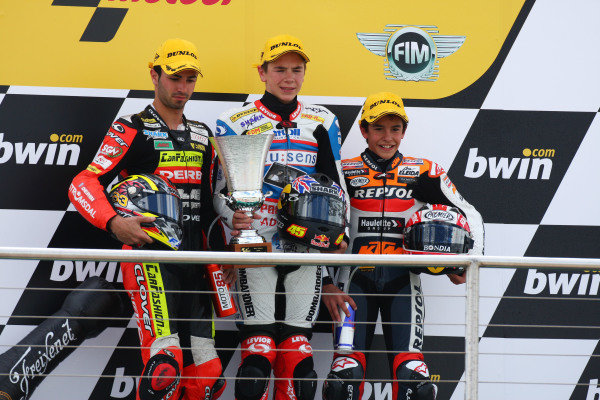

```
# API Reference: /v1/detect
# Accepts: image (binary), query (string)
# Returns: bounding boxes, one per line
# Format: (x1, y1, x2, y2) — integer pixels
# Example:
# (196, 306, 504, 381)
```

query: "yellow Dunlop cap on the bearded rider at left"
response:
(148, 39, 202, 76)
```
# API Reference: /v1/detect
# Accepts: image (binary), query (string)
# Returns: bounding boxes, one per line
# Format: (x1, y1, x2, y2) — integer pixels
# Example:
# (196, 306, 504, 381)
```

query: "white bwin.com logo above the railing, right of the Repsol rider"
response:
(465, 148, 555, 179)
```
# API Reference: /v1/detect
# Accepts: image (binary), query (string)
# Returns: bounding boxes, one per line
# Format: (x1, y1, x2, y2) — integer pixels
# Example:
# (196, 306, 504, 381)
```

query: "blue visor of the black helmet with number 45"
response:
(286, 193, 346, 226)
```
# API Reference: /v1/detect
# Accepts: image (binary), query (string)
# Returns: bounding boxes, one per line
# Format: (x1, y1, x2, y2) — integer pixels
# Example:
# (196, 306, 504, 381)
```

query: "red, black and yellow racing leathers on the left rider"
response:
(69, 105, 224, 399)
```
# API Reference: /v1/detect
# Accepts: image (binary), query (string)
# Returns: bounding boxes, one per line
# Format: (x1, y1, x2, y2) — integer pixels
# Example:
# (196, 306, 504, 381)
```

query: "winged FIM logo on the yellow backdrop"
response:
(356, 24, 466, 82)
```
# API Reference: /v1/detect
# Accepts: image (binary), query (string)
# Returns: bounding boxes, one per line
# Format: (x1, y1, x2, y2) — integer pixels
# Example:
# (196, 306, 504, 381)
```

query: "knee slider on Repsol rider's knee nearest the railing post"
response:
(396, 360, 437, 400)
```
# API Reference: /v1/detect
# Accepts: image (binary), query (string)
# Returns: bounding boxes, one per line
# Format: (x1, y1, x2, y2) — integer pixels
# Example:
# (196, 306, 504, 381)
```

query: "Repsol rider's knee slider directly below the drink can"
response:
(323, 357, 364, 400)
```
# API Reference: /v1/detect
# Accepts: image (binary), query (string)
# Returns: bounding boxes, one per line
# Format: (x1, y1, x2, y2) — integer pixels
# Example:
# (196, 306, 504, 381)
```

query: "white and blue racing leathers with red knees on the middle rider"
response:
(214, 92, 344, 400)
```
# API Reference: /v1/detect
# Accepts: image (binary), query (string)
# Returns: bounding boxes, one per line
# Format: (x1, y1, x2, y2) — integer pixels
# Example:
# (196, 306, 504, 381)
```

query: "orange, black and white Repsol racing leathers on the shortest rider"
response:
(324, 149, 484, 400)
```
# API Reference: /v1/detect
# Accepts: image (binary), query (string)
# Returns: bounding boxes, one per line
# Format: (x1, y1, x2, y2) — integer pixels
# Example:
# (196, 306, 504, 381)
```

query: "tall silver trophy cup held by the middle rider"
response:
(210, 133, 275, 245)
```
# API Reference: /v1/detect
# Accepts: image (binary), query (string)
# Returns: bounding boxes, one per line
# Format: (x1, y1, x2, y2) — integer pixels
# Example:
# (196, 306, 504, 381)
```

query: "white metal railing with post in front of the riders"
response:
(0, 247, 600, 400)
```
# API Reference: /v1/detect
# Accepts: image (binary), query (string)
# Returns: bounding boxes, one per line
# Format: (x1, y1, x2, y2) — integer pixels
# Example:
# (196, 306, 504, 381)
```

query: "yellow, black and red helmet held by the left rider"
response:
(109, 174, 183, 250)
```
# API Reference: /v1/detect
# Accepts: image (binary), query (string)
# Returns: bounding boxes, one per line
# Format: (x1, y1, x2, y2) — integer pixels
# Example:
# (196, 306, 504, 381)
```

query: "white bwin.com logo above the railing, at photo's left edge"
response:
(0, 133, 81, 165)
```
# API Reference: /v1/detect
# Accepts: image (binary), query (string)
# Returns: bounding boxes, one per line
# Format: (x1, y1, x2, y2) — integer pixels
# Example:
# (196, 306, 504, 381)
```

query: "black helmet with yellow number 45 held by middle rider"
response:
(277, 173, 348, 250)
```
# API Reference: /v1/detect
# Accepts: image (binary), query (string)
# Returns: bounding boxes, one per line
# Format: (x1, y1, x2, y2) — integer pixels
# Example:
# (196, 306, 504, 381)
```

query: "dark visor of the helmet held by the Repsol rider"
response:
(404, 221, 473, 254)
